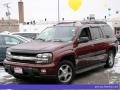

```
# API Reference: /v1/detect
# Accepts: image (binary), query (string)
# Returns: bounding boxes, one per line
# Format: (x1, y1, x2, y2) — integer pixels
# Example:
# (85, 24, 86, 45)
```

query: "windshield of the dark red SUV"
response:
(37, 26, 75, 42)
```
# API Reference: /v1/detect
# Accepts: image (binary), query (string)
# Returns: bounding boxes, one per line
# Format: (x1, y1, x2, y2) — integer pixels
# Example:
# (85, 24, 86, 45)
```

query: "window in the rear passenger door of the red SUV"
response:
(90, 27, 102, 39)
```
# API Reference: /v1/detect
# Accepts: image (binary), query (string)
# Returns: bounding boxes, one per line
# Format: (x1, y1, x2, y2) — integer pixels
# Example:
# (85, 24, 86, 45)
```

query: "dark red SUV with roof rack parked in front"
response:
(4, 21, 118, 84)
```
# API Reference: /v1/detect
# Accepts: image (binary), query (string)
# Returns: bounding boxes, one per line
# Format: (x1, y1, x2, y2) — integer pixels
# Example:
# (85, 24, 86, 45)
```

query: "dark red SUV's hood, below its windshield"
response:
(10, 41, 69, 52)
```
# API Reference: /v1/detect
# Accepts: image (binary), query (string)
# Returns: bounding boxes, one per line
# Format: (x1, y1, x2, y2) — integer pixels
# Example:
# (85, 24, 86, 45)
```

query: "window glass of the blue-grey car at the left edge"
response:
(4, 36, 20, 45)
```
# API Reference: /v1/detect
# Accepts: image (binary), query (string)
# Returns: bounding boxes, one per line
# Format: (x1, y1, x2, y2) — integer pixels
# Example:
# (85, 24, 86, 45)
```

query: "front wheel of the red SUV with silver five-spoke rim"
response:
(57, 60, 75, 84)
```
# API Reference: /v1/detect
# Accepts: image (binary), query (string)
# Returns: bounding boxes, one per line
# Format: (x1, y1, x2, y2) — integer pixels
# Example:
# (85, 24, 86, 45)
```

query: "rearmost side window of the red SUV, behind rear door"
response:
(101, 26, 114, 38)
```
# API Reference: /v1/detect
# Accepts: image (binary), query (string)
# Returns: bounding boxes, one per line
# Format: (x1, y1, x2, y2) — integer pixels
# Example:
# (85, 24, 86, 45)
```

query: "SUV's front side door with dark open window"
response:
(76, 27, 94, 68)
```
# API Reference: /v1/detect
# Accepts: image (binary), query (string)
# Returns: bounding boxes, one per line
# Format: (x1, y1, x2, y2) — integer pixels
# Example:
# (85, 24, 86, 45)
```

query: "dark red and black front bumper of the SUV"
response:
(3, 60, 58, 77)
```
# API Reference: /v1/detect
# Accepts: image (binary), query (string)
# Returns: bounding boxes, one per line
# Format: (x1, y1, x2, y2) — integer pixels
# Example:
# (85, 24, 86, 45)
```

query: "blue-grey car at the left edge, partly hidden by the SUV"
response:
(0, 34, 30, 63)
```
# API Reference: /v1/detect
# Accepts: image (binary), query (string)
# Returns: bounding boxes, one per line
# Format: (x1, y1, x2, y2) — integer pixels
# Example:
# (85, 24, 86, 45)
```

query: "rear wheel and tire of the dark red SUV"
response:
(105, 50, 115, 68)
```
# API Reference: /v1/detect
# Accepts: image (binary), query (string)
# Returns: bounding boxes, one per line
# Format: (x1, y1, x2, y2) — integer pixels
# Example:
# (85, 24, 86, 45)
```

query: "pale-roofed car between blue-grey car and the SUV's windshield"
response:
(13, 32, 39, 39)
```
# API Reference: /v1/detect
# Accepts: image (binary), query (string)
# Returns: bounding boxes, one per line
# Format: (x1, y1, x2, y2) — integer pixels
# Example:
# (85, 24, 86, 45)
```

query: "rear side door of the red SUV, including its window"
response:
(90, 26, 106, 64)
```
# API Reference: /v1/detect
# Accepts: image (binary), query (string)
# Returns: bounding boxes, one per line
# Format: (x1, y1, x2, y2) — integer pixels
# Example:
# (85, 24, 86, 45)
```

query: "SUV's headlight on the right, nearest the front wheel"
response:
(36, 53, 52, 63)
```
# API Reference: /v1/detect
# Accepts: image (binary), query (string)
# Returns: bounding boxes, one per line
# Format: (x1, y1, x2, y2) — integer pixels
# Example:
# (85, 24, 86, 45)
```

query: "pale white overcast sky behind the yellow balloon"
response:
(0, 0, 120, 21)
